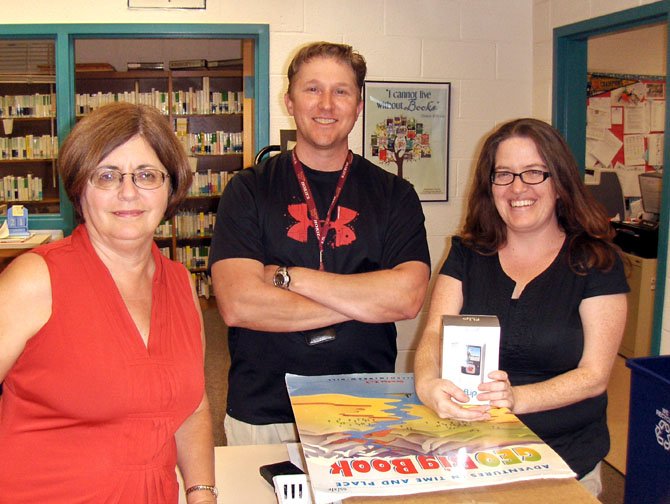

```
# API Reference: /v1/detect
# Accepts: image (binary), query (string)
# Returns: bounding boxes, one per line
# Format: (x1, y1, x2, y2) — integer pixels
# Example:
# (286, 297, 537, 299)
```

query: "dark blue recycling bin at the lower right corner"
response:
(624, 356, 670, 504)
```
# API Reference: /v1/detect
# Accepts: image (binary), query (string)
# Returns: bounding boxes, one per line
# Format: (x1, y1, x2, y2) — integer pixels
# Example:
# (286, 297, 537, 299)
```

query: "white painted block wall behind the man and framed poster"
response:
(1, 0, 668, 362)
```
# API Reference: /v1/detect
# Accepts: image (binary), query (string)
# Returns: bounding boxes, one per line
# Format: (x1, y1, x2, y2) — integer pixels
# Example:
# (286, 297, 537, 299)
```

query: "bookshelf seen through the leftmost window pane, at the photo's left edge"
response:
(0, 79, 60, 215)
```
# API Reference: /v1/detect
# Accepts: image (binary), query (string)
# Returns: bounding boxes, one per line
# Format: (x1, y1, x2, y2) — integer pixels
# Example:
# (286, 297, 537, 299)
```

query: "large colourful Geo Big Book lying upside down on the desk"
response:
(286, 373, 575, 504)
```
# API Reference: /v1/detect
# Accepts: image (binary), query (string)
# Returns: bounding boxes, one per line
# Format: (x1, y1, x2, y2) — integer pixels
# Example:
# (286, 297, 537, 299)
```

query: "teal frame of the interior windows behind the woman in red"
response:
(0, 24, 270, 235)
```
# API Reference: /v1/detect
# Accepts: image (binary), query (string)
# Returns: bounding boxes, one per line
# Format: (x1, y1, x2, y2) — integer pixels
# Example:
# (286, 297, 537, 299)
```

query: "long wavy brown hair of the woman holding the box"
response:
(461, 118, 618, 274)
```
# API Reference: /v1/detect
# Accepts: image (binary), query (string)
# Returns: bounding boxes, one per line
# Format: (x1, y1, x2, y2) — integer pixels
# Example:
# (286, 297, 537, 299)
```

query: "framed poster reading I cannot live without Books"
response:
(363, 81, 451, 201)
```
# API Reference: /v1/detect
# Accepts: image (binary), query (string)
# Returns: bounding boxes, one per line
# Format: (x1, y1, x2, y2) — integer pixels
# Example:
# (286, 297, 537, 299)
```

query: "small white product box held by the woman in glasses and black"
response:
(441, 315, 500, 404)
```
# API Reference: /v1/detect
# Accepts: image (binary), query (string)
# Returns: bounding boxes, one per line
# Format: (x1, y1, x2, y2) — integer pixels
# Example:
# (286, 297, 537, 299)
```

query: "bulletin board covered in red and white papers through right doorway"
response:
(585, 73, 666, 198)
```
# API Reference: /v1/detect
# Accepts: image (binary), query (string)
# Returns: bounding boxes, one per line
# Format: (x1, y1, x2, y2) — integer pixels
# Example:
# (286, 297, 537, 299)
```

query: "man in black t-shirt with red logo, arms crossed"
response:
(210, 42, 430, 445)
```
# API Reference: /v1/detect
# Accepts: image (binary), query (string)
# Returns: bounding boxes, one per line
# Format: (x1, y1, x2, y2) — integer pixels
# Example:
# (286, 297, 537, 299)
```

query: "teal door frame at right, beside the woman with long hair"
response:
(552, 0, 670, 355)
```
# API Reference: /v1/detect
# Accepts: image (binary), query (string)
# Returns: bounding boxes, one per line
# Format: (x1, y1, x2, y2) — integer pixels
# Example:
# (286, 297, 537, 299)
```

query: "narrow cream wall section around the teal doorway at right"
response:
(533, 0, 670, 355)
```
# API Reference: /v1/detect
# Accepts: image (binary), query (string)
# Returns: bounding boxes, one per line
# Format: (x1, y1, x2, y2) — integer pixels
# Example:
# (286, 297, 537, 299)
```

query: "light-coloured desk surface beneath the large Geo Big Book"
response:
(179, 445, 599, 504)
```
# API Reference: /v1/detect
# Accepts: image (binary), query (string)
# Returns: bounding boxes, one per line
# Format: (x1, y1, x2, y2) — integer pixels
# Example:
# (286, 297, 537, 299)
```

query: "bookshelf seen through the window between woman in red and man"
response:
(75, 61, 254, 297)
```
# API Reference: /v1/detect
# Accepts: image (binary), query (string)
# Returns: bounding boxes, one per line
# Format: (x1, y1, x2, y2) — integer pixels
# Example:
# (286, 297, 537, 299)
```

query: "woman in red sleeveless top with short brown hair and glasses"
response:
(0, 103, 216, 504)
